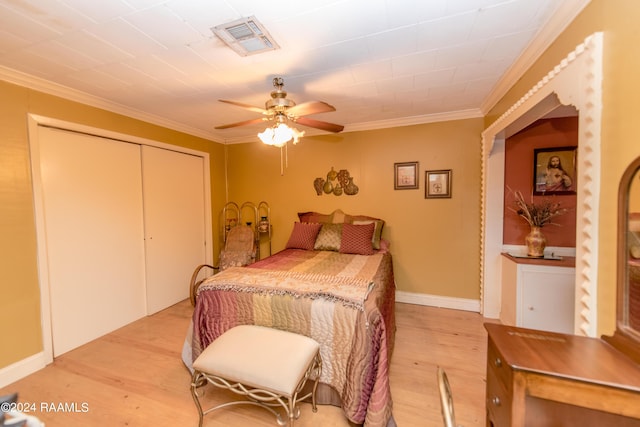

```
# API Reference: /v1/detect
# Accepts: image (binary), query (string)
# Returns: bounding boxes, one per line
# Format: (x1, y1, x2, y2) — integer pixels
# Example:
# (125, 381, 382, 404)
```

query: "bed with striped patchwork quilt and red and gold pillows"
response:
(183, 211, 395, 427)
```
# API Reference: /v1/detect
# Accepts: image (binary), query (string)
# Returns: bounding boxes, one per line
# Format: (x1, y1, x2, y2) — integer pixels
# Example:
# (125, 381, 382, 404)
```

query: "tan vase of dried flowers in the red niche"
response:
(510, 191, 567, 258)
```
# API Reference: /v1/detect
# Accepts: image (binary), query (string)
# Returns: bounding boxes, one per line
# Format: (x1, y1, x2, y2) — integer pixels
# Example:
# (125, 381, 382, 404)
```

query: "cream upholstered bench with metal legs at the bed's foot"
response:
(191, 325, 322, 427)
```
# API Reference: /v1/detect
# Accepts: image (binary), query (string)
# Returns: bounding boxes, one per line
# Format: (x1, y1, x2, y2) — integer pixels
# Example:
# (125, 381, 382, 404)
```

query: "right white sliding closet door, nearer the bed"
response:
(142, 146, 206, 314)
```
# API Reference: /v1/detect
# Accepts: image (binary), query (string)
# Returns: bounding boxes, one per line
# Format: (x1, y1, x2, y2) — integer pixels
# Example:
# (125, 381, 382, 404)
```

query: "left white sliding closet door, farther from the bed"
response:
(39, 127, 145, 356)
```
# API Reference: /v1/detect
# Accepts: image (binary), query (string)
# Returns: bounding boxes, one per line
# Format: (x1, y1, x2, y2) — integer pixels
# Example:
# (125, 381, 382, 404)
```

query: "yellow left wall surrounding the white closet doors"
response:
(0, 81, 224, 368)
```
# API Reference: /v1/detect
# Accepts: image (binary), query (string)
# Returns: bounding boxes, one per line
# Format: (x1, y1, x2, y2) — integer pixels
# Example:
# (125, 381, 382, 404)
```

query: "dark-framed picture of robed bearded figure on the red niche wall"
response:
(533, 147, 578, 196)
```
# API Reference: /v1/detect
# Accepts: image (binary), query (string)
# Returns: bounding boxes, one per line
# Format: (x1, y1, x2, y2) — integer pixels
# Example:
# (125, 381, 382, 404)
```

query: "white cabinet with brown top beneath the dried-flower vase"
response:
(500, 254, 575, 334)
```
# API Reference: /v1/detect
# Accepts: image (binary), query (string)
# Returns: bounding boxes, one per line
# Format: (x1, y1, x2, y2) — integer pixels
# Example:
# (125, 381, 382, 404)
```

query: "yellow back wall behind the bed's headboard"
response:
(228, 119, 483, 300)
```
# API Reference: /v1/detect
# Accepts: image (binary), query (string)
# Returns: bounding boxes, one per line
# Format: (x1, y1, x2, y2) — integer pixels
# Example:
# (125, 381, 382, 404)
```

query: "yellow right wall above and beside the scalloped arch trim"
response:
(486, 0, 640, 334)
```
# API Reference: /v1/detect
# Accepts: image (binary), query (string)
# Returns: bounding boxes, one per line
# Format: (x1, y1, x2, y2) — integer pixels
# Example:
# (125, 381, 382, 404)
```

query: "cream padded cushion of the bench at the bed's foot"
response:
(193, 325, 320, 397)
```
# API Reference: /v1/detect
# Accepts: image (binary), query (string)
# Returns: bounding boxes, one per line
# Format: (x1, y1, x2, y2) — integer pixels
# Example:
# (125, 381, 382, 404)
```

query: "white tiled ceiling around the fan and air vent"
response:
(0, 0, 588, 142)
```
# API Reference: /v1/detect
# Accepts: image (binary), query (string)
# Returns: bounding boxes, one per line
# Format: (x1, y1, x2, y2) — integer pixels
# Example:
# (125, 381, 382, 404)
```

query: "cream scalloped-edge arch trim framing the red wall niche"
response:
(480, 32, 603, 336)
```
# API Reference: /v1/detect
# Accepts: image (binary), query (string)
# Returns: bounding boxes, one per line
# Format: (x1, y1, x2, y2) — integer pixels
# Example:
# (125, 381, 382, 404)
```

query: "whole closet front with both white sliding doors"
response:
(30, 125, 211, 357)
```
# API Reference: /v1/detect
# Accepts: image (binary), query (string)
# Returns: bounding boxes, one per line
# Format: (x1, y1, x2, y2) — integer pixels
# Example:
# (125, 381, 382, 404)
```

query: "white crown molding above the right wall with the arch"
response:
(480, 0, 591, 115)
